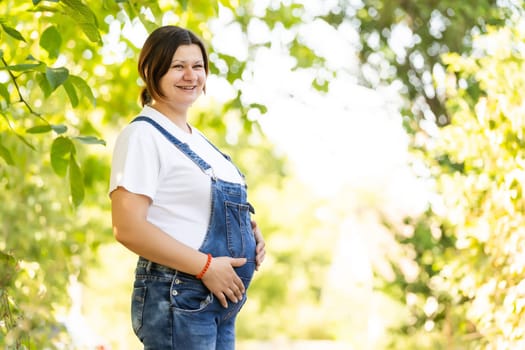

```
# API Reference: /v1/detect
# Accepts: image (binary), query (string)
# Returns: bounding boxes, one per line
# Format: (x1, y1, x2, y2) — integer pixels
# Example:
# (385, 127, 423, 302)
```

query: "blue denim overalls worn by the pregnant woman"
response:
(131, 116, 255, 350)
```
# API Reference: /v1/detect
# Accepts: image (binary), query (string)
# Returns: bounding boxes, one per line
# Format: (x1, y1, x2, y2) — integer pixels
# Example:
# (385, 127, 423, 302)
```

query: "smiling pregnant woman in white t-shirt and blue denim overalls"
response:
(109, 26, 265, 350)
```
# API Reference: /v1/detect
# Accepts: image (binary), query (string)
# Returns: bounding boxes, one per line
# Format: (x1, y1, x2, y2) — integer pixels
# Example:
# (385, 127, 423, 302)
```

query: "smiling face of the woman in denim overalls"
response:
(159, 44, 206, 107)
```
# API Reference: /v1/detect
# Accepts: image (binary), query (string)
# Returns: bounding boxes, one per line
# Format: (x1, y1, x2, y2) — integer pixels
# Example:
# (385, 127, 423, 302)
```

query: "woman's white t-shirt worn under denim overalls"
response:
(109, 106, 244, 249)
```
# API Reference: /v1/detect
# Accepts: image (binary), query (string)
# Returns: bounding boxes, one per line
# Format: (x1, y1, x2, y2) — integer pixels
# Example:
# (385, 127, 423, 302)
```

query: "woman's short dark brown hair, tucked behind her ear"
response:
(138, 25, 209, 106)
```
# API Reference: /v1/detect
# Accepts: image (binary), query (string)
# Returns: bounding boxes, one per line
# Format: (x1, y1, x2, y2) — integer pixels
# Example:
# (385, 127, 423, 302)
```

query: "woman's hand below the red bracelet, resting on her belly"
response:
(202, 256, 246, 308)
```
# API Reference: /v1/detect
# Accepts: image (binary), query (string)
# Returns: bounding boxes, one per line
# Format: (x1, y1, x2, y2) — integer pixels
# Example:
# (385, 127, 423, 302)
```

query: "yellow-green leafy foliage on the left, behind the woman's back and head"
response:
(0, 0, 294, 349)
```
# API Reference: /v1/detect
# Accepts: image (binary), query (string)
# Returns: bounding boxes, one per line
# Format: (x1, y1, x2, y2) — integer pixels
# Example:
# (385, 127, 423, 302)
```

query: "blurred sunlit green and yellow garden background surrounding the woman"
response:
(0, 0, 525, 350)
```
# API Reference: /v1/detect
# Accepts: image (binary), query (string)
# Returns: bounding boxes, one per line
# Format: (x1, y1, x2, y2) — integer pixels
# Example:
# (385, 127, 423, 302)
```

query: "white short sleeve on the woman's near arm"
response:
(109, 123, 160, 200)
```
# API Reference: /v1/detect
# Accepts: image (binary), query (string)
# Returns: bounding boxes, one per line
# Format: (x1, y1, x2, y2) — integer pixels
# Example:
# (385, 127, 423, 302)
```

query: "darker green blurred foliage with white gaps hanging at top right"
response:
(345, 0, 519, 131)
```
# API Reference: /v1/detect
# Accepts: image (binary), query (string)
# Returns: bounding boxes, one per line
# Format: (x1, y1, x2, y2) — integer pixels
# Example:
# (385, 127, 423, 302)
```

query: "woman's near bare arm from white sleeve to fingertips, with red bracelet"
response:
(111, 187, 246, 307)
